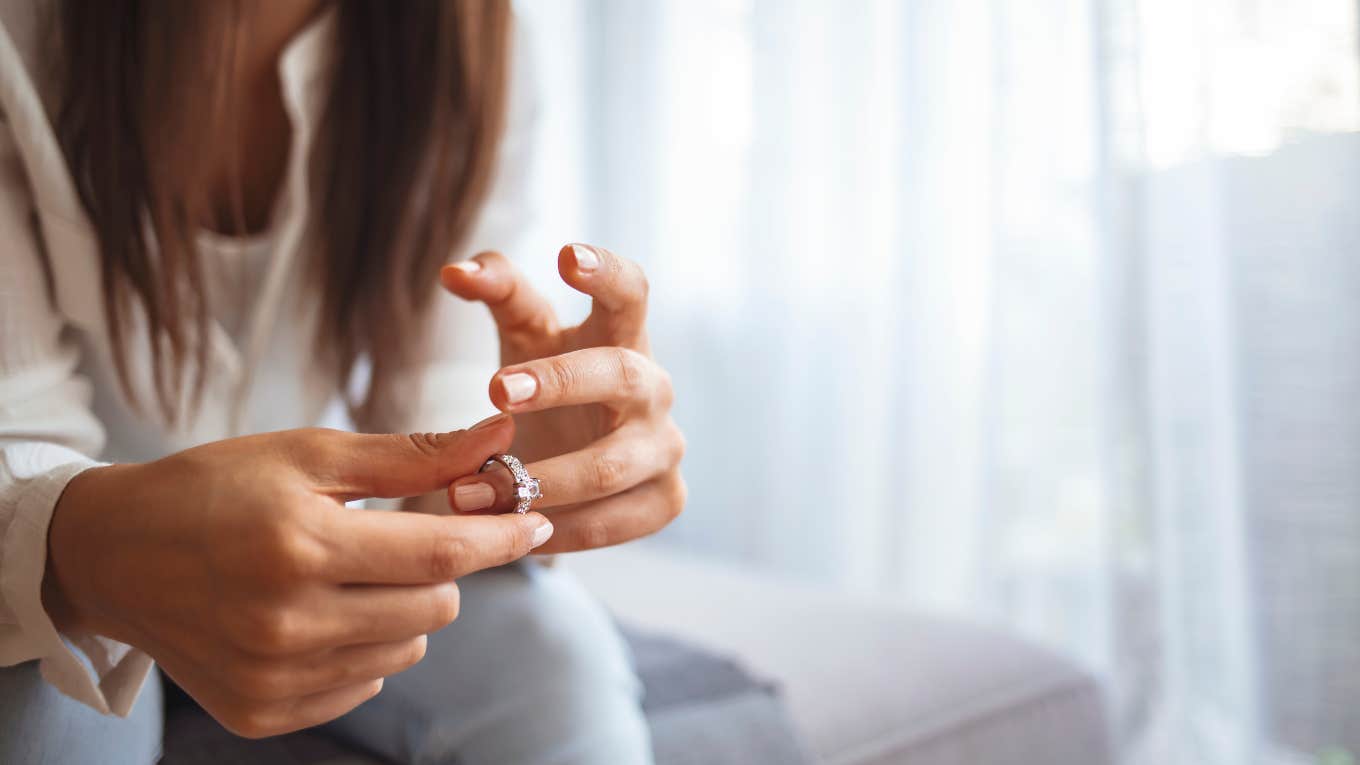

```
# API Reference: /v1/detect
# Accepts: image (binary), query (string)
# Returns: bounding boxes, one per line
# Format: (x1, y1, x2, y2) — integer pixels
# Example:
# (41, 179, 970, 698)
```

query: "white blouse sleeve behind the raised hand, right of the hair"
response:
(359, 19, 549, 433)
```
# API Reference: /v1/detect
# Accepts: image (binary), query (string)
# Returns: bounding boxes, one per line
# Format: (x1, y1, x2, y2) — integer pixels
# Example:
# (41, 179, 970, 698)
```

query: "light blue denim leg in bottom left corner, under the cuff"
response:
(0, 662, 162, 765)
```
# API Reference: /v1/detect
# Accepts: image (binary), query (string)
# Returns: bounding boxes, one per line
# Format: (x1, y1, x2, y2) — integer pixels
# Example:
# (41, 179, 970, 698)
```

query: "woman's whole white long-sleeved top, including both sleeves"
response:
(0, 0, 534, 715)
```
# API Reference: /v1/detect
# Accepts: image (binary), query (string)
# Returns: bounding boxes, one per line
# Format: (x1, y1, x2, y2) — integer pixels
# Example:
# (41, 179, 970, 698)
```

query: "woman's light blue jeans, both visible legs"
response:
(0, 564, 651, 765)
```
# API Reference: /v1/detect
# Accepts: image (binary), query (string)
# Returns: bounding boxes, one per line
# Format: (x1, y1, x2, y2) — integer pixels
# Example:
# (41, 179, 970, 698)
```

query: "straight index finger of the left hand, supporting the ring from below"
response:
(322, 510, 552, 584)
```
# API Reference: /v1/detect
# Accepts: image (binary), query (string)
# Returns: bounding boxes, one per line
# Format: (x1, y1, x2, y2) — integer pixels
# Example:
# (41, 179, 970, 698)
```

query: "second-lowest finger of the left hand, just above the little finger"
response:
(230, 633, 427, 701)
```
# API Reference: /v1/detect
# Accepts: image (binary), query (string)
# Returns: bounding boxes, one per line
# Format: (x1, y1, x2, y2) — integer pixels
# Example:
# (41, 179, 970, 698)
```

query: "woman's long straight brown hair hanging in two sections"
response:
(56, 0, 510, 422)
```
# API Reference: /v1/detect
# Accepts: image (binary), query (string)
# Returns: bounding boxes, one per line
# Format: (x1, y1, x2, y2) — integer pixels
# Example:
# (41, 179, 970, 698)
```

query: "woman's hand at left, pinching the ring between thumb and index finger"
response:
(44, 415, 552, 736)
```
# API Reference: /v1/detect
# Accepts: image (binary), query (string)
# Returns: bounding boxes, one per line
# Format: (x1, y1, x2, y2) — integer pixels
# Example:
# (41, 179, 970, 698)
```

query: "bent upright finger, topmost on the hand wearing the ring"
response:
(558, 244, 647, 350)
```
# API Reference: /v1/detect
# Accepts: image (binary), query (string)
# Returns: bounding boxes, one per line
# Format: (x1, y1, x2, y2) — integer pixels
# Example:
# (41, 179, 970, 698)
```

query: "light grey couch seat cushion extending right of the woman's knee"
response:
(566, 544, 1110, 765)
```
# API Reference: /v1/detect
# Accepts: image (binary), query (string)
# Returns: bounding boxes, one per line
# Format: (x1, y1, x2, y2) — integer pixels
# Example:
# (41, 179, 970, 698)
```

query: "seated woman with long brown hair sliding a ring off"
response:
(0, 0, 684, 762)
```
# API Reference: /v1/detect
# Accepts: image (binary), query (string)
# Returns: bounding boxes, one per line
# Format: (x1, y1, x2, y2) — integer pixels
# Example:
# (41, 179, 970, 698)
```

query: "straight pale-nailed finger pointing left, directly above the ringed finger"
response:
(490, 346, 672, 414)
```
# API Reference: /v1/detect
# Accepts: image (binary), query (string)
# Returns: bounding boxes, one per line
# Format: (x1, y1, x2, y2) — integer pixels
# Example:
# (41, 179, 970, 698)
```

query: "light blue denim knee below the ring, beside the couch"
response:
(329, 564, 651, 764)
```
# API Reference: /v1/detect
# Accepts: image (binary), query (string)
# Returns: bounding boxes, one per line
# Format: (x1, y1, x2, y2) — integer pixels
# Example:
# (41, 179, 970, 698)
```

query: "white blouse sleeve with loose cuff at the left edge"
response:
(0, 116, 151, 716)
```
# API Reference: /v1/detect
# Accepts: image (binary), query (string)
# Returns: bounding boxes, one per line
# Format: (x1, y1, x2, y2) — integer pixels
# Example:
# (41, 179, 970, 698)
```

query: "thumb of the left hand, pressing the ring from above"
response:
(313, 414, 514, 501)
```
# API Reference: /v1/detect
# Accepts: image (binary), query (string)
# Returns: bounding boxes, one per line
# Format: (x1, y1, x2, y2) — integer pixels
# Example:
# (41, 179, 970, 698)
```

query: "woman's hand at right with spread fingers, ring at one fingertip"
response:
(441, 245, 685, 553)
